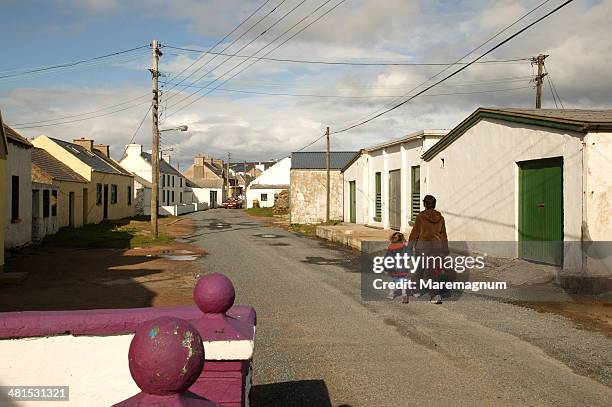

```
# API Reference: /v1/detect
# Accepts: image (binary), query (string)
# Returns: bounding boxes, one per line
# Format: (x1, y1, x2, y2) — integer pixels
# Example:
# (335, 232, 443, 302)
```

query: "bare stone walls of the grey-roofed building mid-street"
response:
(289, 169, 343, 224)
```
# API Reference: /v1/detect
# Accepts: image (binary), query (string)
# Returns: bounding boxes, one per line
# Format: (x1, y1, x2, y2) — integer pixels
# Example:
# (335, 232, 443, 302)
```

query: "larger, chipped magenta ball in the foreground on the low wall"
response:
(129, 317, 204, 395)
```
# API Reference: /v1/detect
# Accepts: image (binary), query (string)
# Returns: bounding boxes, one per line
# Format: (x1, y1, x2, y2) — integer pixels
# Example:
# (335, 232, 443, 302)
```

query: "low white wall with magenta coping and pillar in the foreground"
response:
(0, 305, 256, 406)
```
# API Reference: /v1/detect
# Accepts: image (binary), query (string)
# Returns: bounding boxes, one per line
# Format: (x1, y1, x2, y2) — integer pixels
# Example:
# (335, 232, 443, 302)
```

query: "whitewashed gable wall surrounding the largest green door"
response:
(427, 120, 582, 262)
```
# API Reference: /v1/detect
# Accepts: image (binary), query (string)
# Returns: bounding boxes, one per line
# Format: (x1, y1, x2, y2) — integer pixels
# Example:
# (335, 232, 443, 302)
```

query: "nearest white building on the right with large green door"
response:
(421, 108, 612, 277)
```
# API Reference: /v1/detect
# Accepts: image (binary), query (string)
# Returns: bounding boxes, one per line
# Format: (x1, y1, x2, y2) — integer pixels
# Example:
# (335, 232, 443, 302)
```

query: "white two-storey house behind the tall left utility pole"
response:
(119, 144, 192, 215)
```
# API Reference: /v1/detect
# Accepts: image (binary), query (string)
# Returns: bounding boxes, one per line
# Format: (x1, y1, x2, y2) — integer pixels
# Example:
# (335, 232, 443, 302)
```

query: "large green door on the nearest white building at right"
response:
(519, 158, 563, 265)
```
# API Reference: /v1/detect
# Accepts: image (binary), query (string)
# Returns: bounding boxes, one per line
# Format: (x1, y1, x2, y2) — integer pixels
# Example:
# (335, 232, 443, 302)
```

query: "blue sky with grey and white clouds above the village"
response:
(0, 0, 612, 167)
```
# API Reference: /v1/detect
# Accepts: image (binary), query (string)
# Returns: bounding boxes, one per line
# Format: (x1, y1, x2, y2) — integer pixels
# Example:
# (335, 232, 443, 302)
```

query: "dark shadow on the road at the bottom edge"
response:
(251, 380, 342, 407)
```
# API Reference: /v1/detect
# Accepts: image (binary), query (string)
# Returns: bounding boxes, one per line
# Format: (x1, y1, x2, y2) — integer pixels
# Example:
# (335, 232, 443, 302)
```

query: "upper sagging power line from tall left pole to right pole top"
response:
(164, 45, 530, 66)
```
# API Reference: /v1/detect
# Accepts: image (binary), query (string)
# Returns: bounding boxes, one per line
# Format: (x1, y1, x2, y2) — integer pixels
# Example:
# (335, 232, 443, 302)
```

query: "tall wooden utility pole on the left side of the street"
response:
(151, 40, 162, 239)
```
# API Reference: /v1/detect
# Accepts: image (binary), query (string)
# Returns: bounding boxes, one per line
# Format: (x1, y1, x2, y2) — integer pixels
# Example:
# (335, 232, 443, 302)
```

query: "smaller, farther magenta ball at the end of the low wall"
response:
(193, 273, 236, 314)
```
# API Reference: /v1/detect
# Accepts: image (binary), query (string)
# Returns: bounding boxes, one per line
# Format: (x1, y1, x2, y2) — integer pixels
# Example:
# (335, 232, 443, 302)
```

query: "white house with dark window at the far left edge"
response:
(2, 125, 33, 249)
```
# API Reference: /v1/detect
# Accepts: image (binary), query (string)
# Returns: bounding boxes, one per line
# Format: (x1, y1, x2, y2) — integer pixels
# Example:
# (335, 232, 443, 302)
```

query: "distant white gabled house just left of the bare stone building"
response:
(246, 157, 291, 208)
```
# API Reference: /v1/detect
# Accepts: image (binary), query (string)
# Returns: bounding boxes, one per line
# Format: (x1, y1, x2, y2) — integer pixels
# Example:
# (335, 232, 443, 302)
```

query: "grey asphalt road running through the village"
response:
(190, 209, 612, 406)
